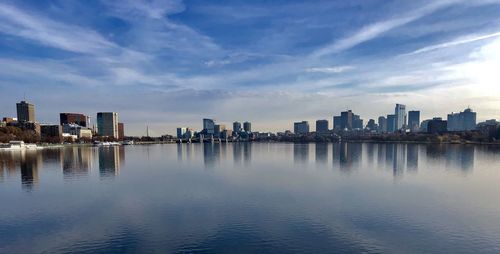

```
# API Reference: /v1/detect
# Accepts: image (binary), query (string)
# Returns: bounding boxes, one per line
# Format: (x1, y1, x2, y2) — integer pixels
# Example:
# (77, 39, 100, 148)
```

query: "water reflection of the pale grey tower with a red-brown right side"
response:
(98, 146, 124, 177)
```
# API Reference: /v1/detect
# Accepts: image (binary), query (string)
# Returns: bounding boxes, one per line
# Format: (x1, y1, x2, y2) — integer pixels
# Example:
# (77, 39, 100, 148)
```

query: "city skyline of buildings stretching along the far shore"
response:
(0, 100, 486, 137)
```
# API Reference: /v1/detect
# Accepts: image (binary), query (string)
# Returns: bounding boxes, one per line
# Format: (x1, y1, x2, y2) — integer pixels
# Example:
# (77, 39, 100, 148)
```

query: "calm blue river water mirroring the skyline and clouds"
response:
(0, 143, 500, 253)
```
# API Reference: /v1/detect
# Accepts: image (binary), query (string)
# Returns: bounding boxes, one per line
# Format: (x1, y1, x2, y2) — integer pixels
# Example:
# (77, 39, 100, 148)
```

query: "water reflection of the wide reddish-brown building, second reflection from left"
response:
(60, 147, 93, 178)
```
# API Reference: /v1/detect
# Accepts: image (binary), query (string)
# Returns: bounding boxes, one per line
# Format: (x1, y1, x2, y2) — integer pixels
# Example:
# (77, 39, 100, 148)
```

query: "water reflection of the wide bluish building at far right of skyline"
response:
(445, 145, 475, 172)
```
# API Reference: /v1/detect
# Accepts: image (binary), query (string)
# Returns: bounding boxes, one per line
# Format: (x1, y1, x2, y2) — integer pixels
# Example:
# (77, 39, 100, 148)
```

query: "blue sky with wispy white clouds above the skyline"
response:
(0, 0, 500, 135)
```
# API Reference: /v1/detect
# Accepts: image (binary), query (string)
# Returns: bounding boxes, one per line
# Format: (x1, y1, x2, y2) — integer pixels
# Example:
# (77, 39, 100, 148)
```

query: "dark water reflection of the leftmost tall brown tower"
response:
(19, 151, 43, 191)
